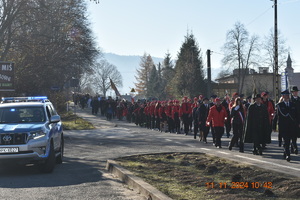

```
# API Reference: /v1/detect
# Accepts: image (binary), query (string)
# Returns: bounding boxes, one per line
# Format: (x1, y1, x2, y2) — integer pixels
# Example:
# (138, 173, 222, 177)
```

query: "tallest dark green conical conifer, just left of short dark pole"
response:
(172, 34, 205, 97)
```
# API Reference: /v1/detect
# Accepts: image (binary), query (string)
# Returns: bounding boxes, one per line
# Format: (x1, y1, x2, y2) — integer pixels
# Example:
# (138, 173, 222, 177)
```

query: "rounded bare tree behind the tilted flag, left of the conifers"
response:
(89, 60, 123, 97)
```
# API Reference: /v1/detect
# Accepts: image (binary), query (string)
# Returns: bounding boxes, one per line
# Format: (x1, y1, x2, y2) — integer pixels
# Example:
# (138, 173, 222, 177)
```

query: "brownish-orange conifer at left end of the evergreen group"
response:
(135, 53, 154, 96)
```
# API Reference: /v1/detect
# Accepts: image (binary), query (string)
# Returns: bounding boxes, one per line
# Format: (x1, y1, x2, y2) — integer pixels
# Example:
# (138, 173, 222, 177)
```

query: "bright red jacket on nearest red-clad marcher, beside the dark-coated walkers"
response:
(206, 105, 227, 127)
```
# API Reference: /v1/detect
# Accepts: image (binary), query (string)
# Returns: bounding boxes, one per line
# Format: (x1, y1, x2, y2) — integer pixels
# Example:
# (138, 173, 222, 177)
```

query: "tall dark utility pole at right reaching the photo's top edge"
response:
(273, 0, 280, 102)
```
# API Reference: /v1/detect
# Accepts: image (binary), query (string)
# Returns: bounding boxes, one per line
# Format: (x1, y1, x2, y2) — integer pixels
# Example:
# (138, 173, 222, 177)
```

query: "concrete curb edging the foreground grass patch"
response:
(106, 160, 172, 200)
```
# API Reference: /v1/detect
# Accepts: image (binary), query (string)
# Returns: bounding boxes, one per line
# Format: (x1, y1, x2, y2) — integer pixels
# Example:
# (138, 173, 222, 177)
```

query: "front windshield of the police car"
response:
(0, 107, 46, 124)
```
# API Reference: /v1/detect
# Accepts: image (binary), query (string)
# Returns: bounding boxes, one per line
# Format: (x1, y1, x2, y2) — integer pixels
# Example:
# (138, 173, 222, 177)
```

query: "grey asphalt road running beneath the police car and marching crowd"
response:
(0, 110, 300, 200)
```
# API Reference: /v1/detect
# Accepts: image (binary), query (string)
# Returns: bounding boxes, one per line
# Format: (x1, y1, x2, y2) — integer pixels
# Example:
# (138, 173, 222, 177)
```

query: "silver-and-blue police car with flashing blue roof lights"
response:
(0, 96, 64, 173)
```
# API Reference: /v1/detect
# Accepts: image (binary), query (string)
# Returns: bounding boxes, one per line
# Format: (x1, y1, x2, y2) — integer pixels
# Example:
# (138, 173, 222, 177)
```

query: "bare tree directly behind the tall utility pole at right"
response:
(262, 29, 289, 72)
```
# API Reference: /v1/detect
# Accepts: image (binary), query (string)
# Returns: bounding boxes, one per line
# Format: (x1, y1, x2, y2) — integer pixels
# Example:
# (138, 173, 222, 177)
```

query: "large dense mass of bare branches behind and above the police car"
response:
(0, 0, 98, 95)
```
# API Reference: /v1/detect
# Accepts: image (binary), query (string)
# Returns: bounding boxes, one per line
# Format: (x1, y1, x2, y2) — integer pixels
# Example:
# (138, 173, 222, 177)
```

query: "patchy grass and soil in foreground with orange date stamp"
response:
(116, 153, 300, 200)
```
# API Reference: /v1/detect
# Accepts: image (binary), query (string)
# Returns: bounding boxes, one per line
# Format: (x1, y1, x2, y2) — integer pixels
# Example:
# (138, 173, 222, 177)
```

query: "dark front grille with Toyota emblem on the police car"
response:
(0, 133, 28, 145)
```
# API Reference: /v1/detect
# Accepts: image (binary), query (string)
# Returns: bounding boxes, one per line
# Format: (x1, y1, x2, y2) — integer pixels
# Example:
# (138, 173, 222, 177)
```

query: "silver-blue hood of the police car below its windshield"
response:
(0, 124, 44, 132)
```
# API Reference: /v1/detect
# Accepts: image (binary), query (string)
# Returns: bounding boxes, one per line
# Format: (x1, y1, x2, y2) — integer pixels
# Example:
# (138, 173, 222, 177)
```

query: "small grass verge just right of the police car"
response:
(60, 112, 95, 130)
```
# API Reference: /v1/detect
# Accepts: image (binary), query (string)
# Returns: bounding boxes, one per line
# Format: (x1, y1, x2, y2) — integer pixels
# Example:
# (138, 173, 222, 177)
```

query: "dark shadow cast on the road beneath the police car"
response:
(0, 157, 105, 188)
